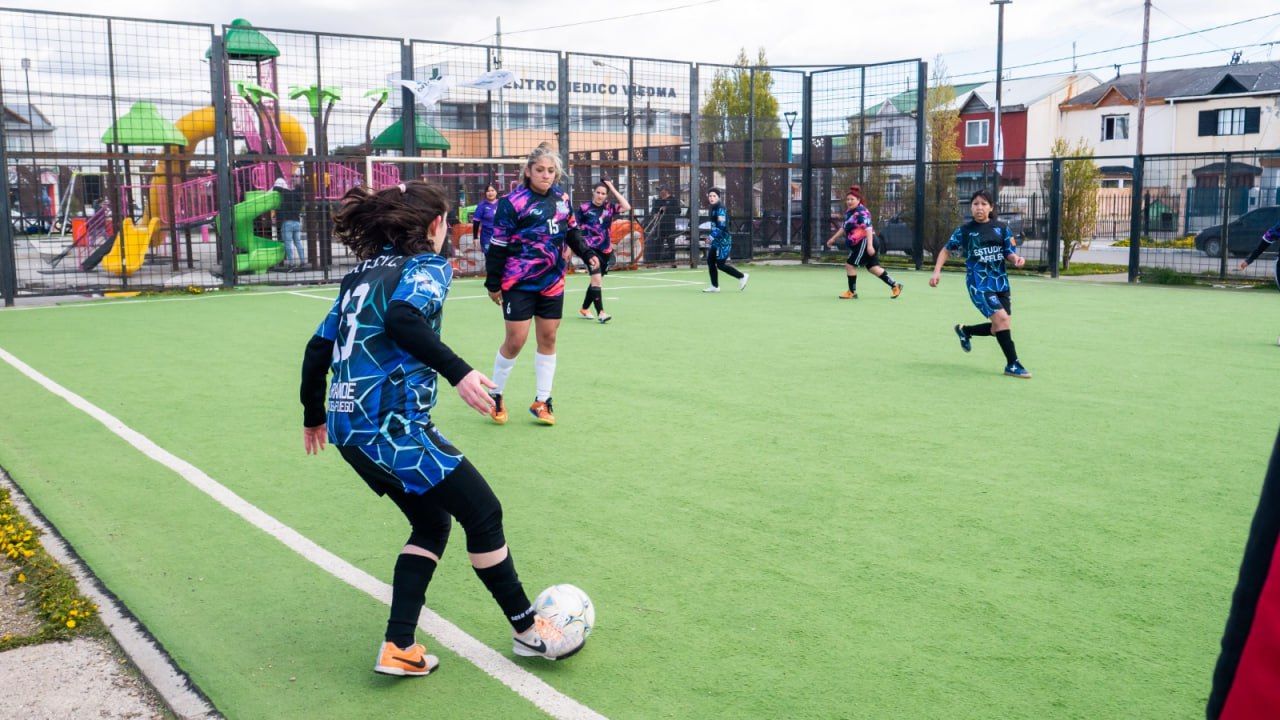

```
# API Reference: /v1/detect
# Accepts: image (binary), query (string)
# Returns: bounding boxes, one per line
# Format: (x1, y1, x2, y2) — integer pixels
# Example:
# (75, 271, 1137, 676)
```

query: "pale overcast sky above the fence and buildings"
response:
(10, 0, 1280, 82)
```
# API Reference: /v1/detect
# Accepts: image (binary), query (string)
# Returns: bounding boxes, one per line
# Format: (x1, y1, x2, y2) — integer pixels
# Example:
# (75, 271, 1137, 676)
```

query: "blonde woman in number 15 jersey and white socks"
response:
(484, 143, 600, 425)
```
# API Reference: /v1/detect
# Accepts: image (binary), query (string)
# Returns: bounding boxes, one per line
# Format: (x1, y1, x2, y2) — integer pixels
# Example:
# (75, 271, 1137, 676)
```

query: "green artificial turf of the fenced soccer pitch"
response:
(0, 266, 1280, 719)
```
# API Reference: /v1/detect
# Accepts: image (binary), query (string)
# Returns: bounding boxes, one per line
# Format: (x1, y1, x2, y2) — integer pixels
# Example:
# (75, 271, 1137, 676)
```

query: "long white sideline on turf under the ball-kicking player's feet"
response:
(0, 348, 604, 720)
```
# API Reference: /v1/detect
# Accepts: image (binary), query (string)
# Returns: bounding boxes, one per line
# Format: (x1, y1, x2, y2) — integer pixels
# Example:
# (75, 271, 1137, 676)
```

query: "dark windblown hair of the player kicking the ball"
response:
(333, 181, 449, 260)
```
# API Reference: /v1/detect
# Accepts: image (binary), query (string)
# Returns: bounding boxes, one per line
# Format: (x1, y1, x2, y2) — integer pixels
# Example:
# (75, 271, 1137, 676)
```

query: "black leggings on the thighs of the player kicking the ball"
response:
(338, 446, 507, 557)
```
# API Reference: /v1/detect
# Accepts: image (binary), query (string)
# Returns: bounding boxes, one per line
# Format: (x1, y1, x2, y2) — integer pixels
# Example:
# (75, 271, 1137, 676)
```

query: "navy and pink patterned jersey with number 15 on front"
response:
(490, 184, 577, 297)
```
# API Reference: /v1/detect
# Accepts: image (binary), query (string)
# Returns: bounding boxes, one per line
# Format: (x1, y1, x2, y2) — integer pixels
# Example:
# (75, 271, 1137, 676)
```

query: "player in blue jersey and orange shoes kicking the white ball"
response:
(300, 181, 582, 675)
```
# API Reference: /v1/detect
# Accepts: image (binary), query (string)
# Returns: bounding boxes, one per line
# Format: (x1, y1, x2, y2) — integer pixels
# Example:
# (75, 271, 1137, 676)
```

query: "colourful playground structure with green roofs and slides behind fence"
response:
(29, 20, 424, 277)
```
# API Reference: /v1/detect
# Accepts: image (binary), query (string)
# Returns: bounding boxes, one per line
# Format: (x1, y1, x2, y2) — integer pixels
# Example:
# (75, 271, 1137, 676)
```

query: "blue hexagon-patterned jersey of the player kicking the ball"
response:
(316, 254, 453, 445)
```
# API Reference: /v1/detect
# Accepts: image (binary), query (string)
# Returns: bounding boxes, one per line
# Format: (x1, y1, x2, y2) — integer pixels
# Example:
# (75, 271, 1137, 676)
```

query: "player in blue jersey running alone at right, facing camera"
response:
(929, 190, 1032, 378)
